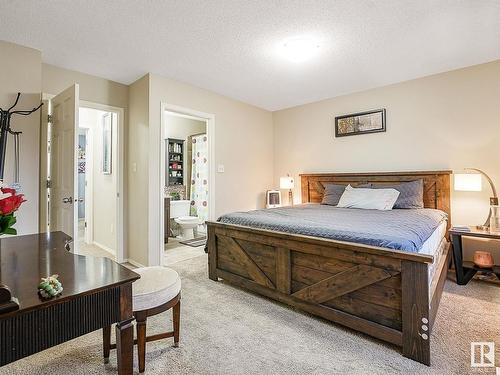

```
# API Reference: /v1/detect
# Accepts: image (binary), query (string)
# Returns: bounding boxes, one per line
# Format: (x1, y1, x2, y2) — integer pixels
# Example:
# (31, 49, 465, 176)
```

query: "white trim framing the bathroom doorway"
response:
(152, 102, 216, 265)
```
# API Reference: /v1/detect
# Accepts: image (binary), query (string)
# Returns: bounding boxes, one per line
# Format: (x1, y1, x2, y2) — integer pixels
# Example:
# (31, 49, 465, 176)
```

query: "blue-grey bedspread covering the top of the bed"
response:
(218, 204, 446, 253)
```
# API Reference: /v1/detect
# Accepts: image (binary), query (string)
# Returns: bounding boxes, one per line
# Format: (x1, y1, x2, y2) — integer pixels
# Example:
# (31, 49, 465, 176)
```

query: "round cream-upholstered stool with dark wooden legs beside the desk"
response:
(103, 267, 181, 372)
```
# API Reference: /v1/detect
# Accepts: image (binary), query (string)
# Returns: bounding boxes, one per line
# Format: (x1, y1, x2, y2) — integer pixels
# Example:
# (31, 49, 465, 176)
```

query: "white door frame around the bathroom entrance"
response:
(156, 102, 216, 265)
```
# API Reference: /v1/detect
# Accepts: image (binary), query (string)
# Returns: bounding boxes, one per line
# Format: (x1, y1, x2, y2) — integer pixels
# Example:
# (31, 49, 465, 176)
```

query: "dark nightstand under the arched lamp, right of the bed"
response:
(449, 227, 500, 285)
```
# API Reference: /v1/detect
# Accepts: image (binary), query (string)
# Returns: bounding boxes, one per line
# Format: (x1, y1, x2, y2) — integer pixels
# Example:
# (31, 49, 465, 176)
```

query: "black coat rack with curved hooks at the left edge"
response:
(0, 92, 43, 183)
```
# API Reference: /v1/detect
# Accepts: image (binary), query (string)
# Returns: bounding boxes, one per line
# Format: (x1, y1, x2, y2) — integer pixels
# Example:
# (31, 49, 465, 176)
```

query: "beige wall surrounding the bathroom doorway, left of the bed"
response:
(129, 74, 273, 264)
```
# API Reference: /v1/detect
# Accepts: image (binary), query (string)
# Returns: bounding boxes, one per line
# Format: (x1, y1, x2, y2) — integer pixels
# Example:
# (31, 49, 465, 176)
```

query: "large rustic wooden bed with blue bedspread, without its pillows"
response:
(207, 171, 451, 365)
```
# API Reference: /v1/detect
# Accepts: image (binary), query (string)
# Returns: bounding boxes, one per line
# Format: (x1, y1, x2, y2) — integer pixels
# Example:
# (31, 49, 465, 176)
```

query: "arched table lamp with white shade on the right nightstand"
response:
(454, 168, 500, 232)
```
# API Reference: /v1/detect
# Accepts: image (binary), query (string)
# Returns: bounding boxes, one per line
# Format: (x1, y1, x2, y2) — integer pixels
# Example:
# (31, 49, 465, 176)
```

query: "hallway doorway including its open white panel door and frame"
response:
(40, 84, 126, 262)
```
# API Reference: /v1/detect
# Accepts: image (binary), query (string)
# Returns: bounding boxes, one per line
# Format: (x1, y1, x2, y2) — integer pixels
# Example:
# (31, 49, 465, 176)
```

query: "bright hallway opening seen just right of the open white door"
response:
(76, 106, 119, 260)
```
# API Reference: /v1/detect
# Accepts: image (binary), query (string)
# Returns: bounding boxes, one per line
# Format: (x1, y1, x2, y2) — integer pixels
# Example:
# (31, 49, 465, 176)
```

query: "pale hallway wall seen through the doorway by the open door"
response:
(79, 108, 118, 254)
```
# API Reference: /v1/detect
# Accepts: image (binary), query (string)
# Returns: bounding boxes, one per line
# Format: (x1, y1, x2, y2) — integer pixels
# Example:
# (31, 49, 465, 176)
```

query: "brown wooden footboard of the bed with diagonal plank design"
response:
(208, 222, 448, 365)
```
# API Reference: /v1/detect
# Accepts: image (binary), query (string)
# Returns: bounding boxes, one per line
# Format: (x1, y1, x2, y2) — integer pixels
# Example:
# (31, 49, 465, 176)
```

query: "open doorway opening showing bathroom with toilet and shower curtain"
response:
(163, 111, 212, 264)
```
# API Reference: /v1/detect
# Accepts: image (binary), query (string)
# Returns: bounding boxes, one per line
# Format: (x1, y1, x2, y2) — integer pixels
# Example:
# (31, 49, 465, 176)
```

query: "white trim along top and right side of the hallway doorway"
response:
(80, 100, 127, 263)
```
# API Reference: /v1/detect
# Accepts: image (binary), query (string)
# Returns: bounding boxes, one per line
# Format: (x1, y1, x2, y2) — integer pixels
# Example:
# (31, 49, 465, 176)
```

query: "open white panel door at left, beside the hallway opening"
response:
(50, 84, 79, 251)
